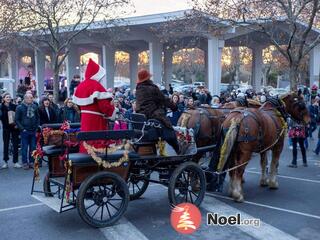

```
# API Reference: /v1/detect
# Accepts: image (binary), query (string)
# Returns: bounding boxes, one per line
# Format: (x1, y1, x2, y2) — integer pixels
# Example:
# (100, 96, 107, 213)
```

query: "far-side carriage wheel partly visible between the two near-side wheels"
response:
(128, 169, 150, 201)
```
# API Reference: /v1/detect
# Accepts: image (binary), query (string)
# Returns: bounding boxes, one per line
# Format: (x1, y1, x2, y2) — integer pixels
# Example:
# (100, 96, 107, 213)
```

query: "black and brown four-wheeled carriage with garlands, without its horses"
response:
(31, 114, 215, 227)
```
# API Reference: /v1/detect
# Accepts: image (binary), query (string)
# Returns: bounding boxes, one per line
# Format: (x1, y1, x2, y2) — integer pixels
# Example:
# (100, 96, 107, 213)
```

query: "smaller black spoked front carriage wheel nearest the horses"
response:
(168, 162, 206, 206)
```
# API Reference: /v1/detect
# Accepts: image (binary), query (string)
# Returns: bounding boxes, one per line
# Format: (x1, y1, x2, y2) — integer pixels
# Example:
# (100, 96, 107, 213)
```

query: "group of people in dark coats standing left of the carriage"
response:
(0, 91, 80, 169)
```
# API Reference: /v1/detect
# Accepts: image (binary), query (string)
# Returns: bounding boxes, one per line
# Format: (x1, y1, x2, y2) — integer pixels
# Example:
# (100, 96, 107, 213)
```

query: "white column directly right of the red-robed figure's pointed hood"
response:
(101, 45, 116, 88)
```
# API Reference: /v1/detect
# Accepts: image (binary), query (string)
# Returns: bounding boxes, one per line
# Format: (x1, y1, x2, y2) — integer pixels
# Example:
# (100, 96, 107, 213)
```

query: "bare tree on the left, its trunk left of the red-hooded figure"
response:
(16, 0, 129, 101)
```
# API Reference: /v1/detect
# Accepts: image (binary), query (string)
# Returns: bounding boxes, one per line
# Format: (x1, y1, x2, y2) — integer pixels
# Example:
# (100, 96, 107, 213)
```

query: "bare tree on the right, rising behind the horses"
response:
(193, 0, 320, 90)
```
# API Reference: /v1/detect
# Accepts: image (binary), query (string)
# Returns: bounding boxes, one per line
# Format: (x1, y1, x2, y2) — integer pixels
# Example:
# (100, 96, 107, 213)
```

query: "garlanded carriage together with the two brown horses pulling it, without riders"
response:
(31, 94, 310, 227)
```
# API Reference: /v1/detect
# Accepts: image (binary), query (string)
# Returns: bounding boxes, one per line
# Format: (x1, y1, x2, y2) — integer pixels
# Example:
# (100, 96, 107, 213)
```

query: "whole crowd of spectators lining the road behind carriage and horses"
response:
(0, 73, 320, 169)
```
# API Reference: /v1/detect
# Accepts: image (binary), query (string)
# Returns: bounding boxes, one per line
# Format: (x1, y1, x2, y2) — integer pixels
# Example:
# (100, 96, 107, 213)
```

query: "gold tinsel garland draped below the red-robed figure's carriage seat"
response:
(83, 141, 131, 168)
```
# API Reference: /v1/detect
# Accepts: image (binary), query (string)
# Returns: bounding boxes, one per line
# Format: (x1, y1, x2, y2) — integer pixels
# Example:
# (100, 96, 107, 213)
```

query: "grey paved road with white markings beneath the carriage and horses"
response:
(0, 135, 320, 240)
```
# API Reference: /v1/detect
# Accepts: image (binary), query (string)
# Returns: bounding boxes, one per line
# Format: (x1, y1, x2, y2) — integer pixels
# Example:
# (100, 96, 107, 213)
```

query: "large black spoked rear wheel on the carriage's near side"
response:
(77, 172, 129, 228)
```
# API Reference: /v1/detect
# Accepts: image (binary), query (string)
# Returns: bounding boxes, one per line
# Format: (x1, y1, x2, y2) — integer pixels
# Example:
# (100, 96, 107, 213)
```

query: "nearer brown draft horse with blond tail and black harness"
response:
(218, 93, 310, 202)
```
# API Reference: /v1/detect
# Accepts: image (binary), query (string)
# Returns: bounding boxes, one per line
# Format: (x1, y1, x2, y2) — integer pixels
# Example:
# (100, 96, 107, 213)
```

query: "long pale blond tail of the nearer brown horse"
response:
(217, 119, 239, 171)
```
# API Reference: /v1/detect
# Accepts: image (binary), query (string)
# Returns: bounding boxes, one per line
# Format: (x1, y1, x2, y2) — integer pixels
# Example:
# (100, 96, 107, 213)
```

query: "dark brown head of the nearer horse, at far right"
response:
(279, 92, 310, 124)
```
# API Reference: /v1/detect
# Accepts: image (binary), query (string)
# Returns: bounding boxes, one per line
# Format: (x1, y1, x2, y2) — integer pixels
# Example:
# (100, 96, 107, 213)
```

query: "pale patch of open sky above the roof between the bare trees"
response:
(128, 0, 191, 16)
